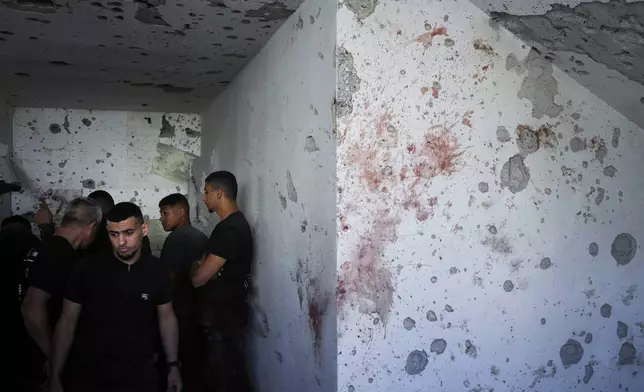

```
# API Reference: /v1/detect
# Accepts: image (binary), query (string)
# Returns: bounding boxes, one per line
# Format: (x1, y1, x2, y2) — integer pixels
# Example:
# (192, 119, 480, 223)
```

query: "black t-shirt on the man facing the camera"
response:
(65, 252, 171, 382)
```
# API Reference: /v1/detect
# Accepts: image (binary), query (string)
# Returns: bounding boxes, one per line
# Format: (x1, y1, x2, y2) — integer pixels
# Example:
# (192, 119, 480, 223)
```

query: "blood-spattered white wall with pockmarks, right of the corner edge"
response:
(337, 0, 644, 391)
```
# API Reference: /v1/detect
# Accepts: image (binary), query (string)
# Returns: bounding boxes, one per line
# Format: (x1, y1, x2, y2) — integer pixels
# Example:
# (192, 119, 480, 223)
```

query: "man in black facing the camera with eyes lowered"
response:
(50, 202, 181, 392)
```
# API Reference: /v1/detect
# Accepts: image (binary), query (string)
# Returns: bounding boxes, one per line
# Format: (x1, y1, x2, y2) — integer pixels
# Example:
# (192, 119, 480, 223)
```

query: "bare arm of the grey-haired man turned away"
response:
(21, 287, 51, 357)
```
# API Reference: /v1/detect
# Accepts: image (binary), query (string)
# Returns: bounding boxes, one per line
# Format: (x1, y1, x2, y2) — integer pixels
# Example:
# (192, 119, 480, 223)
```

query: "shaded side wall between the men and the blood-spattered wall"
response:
(193, 0, 336, 391)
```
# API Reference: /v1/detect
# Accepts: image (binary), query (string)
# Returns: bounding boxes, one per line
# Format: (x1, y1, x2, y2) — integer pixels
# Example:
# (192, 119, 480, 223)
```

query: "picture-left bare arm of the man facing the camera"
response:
(49, 299, 83, 385)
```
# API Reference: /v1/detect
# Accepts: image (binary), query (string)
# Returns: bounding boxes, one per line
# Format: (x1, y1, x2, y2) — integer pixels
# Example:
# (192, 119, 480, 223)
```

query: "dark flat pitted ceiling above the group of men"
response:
(0, 0, 303, 113)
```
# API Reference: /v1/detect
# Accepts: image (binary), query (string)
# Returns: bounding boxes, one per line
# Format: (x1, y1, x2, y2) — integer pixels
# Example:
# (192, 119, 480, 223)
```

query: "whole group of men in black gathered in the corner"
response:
(6, 171, 253, 392)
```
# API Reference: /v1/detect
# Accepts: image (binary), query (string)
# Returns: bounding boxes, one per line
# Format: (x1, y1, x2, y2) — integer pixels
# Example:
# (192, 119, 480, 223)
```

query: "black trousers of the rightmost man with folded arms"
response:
(204, 328, 251, 392)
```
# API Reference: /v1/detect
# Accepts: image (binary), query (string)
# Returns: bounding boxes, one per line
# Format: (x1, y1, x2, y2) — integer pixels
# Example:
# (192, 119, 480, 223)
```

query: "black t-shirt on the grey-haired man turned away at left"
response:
(24, 235, 78, 328)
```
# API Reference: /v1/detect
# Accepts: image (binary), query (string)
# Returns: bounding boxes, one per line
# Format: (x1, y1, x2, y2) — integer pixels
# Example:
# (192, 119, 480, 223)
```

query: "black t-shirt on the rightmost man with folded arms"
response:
(202, 211, 253, 329)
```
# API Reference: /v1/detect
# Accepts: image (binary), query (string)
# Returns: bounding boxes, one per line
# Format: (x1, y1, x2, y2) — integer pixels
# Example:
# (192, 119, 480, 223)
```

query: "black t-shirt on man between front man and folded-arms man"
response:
(161, 225, 208, 327)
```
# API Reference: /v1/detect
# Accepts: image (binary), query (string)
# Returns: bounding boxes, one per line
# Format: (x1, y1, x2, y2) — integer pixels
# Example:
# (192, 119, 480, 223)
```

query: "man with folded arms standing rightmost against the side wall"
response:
(192, 171, 253, 392)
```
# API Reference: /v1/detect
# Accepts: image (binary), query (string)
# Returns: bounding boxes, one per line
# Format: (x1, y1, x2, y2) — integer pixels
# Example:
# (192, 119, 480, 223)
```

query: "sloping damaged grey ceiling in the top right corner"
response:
(471, 0, 644, 132)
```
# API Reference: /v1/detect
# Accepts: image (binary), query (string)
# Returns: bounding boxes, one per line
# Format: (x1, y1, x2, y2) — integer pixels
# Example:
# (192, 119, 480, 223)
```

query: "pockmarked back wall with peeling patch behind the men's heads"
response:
(13, 108, 201, 251)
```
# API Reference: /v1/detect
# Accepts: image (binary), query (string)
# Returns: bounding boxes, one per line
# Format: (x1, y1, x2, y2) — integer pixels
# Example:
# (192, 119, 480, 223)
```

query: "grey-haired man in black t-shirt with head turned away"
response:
(22, 198, 102, 388)
